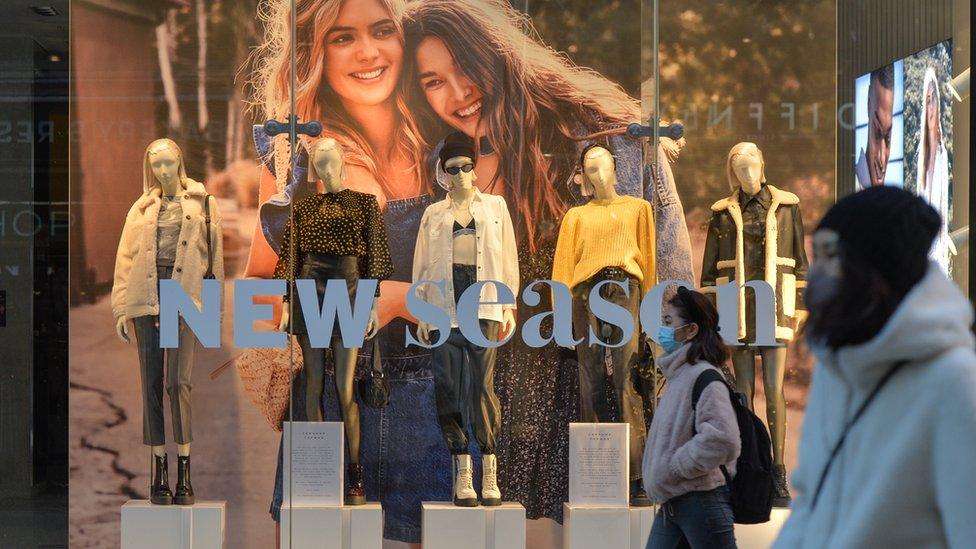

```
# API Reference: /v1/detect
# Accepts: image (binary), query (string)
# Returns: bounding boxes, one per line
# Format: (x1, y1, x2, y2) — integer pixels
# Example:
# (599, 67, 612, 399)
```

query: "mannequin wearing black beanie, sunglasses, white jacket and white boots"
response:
(413, 133, 519, 507)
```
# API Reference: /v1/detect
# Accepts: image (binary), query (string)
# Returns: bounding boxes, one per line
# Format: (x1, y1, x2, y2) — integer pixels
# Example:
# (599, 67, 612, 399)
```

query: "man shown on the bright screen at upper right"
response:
(857, 65, 895, 189)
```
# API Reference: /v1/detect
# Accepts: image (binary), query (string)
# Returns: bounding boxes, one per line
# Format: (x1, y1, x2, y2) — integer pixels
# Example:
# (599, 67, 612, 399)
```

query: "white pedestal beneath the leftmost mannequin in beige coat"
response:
(122, 499, 227, 549)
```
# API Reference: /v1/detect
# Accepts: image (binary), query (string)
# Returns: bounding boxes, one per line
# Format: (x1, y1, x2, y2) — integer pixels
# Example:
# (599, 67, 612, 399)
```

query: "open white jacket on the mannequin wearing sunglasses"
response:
(413, 189, 519, 328)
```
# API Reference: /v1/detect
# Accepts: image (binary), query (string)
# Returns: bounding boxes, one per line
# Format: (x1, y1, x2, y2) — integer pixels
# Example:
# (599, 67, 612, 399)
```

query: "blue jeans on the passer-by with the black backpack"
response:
(647, 486, 735, 549)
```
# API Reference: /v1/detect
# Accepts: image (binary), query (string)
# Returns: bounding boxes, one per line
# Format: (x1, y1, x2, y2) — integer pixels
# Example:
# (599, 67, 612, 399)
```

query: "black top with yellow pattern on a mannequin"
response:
(274, 189, 393, 300)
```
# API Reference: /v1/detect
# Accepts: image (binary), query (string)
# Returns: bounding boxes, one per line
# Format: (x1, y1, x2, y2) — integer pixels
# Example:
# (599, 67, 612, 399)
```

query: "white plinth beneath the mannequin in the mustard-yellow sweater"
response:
(563, 503, 654, 549)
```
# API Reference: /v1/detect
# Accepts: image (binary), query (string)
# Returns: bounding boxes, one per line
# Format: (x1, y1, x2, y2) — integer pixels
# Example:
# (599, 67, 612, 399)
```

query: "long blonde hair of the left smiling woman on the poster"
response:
(250, 0, 425, 195)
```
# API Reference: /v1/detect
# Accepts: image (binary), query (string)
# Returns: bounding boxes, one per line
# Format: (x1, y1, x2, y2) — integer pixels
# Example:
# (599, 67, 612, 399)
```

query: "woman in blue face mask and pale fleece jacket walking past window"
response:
(643, 288, 741, 549)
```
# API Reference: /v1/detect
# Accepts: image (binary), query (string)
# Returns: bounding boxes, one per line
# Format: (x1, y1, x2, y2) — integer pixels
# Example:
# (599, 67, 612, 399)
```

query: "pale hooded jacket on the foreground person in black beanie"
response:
(775, 263, 976, 549)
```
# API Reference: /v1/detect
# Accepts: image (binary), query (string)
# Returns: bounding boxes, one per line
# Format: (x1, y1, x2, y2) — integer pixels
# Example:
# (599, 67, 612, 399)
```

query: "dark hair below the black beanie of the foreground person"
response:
(803, 242, 905, 349)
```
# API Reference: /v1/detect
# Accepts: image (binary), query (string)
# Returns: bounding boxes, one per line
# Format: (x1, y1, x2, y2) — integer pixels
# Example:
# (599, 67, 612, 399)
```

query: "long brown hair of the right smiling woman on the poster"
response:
(401, 0, 640, 251)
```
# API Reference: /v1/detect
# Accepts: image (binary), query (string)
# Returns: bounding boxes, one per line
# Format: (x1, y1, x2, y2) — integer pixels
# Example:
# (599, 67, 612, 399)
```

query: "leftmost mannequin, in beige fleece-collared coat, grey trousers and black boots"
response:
(112, 139, 224, 505)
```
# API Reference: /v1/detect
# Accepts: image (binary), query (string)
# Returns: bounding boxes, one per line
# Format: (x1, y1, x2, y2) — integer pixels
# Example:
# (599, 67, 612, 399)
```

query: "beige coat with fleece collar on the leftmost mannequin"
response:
(112, 179, 224, 319)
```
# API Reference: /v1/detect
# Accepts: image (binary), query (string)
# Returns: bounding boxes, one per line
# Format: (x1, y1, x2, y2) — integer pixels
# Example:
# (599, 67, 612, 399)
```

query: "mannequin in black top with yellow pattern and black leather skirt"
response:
(275, 138, 393, 505)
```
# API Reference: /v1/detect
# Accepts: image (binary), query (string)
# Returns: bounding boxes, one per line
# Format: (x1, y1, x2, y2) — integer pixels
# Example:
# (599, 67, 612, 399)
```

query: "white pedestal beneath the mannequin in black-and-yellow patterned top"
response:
(281, 503, 383, 549)
